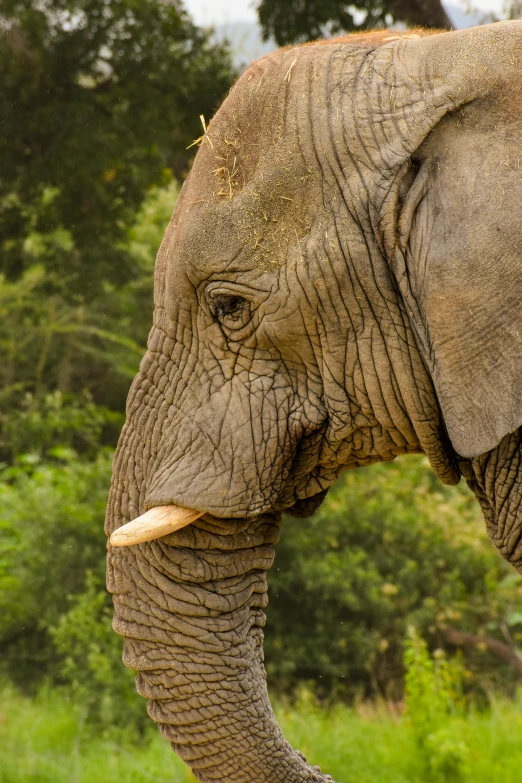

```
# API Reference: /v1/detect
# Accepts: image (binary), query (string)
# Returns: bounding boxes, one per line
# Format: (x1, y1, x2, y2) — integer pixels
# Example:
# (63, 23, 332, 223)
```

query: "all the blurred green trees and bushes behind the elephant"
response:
(0, 0, 522, 783)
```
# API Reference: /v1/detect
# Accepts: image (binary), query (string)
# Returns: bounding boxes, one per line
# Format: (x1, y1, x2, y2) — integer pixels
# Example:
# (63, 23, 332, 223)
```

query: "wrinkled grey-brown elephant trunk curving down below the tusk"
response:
(108, 515, 331, 783)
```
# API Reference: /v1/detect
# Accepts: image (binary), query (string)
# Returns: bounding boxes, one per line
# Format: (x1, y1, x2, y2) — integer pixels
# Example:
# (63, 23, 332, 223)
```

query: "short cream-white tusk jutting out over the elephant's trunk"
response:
(111, 506, 205, 546)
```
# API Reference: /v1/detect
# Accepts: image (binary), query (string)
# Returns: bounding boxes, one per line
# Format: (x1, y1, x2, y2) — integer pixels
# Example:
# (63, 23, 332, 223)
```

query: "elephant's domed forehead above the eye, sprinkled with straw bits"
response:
(165, 50, 334, 278)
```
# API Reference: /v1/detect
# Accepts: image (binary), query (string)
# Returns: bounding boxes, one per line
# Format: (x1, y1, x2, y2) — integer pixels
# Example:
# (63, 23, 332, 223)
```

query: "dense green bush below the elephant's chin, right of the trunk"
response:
(265, 457, 522, 701)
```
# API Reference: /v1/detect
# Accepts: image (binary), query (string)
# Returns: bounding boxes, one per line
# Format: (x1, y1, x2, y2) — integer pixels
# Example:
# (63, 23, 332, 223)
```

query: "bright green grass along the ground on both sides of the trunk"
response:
(0, 690, 522, 783)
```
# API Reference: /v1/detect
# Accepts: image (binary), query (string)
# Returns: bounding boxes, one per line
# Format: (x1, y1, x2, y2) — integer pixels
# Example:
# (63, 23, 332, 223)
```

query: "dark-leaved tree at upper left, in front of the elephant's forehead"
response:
(0, 0, 233, 301)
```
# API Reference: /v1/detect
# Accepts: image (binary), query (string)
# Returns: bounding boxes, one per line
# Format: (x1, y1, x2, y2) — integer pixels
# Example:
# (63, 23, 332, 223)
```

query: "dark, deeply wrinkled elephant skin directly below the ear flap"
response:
(461, 428, 522, 573)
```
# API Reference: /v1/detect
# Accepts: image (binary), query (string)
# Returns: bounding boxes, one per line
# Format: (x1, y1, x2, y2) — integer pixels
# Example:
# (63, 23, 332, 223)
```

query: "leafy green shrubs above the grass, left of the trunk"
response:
(0, 447, 147, 735)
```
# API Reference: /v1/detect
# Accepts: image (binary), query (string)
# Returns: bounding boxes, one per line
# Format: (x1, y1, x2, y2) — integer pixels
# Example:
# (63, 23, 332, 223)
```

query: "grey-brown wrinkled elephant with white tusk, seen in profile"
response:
(106, 22, 522, 783)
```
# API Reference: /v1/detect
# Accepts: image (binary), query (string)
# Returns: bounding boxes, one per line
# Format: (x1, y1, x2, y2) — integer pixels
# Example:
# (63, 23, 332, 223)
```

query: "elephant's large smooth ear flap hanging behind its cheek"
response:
(395, 145, 522, 457)
